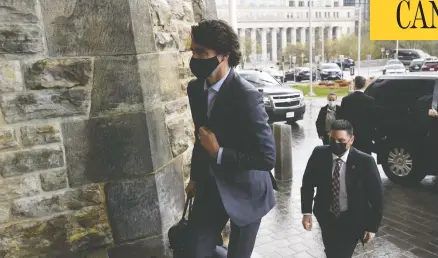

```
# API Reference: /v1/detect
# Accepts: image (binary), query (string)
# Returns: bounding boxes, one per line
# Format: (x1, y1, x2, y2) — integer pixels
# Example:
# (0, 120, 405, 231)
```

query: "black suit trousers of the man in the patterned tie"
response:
(318, 211, 358, 258)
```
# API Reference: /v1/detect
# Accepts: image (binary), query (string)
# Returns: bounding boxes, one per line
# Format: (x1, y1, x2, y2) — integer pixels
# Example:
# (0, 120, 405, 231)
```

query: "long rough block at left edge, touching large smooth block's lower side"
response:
(0, 146, 64, 177)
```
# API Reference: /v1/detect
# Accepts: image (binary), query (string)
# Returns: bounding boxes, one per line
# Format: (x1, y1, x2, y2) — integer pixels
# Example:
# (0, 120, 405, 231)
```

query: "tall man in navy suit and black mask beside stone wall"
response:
(186, 20, 276, 258)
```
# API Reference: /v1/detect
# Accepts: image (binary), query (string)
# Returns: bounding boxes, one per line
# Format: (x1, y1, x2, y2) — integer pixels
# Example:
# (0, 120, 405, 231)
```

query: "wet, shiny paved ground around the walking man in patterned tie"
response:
(255, 99, 438, 258)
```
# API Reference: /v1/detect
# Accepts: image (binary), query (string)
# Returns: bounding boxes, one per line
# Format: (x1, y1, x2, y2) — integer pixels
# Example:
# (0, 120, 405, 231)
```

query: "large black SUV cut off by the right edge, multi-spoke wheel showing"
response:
(365, 72, 438, 185)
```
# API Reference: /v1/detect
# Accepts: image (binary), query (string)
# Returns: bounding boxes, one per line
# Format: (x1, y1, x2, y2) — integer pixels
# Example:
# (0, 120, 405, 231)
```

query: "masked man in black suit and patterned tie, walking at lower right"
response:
(301, 120, 382, 258)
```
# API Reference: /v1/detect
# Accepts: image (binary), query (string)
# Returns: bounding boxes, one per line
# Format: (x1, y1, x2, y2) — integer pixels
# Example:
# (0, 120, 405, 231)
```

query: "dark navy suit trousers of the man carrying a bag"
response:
(190, 176, 261, 258)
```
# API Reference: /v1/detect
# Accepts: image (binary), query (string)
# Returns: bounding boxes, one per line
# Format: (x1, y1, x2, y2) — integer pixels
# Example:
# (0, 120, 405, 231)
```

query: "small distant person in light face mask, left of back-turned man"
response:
(316, 92, 341, 145)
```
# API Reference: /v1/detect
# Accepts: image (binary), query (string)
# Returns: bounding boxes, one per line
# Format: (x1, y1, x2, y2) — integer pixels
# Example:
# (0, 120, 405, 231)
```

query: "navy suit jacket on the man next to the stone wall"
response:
(187, 69, 276, 226)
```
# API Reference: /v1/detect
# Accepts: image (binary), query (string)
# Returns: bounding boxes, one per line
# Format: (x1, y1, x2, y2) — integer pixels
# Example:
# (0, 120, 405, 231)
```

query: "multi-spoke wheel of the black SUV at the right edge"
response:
(382, 146, 426, 186)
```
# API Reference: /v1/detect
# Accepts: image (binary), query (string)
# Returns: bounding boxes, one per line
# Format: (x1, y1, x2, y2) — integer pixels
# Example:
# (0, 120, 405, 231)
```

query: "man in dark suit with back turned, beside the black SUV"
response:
(339, 76, 376, 154)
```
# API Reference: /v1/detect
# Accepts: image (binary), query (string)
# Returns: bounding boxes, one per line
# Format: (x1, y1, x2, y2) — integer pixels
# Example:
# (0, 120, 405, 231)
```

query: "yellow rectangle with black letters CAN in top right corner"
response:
(370, 0, 438, 40)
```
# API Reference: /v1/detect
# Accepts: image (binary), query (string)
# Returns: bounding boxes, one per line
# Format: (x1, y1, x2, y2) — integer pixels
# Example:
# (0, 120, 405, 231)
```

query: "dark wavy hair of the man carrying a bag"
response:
(192, 20, 242, 67)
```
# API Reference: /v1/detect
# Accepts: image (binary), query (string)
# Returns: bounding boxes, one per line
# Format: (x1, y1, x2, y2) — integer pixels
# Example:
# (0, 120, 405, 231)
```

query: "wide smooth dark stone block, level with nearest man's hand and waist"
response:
(62, 113, 167, 186)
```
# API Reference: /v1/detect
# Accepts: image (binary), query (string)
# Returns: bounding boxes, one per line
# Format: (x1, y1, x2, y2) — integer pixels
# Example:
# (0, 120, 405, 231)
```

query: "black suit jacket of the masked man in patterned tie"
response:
(301, 146, 383, 239)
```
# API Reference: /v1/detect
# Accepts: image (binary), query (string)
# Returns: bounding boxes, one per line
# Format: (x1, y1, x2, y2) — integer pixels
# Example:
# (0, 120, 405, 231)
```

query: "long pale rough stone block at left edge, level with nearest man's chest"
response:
(0, 88, 89, 123)
